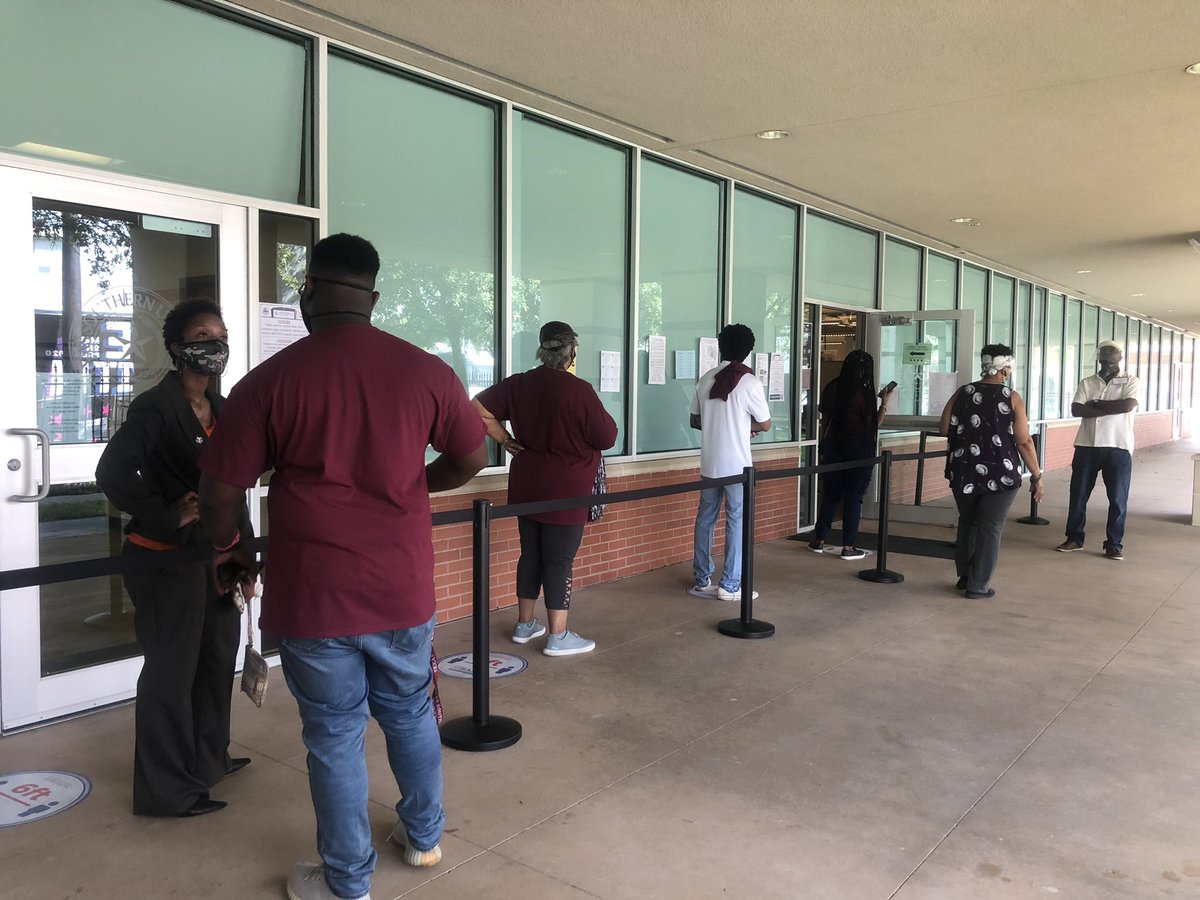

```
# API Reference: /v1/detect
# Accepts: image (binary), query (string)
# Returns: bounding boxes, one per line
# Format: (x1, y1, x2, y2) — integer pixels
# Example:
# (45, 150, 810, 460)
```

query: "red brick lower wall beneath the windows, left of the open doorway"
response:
(432, 448, 799, 622)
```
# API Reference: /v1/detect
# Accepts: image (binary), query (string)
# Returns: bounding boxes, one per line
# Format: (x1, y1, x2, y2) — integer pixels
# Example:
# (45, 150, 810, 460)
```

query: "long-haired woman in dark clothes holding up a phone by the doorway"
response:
(809, 350, 892, 559)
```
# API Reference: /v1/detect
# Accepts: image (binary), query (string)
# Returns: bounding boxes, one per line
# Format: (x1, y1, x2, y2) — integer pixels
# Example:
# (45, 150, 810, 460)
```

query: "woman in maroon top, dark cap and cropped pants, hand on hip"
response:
(473, 322, 617, 656)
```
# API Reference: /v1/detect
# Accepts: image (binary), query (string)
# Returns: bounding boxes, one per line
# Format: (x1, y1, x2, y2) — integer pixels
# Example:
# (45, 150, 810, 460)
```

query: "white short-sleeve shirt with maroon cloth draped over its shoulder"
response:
(690, 361, 770, 478)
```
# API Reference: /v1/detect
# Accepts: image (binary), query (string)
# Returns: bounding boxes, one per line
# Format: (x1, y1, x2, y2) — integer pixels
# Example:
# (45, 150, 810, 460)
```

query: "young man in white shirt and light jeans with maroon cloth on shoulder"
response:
(688, 325, 770, 600)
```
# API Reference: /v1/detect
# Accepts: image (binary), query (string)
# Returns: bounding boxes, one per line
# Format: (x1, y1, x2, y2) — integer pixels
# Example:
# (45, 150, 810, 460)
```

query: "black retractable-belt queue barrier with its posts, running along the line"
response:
(0, 450, 946, 751)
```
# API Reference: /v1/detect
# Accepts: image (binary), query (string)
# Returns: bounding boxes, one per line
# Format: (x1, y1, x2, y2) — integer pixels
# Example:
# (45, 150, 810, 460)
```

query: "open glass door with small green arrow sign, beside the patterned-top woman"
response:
(864, 310, 977, 524)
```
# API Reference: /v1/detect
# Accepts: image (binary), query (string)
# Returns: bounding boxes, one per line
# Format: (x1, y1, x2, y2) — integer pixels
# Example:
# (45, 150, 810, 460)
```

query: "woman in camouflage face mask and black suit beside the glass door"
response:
(96, 300, 252, 816)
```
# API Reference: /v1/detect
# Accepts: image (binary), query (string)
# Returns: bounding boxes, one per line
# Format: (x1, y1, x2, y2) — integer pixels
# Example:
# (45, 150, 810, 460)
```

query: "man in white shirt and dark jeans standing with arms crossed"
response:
(1056, 341, 1138, 559)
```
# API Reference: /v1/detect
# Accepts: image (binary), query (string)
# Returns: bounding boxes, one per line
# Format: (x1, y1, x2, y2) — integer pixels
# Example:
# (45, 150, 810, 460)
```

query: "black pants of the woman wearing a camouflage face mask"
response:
(125, 541, 239, 816)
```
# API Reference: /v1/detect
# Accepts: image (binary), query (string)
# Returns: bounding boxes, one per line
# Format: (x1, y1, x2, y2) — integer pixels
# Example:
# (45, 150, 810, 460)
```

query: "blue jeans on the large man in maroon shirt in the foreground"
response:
(280, 618, 445, 898)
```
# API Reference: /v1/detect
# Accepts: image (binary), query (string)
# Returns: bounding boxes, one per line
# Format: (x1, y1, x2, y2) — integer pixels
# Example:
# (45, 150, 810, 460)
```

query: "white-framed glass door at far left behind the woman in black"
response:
(0, 168, 248, 730)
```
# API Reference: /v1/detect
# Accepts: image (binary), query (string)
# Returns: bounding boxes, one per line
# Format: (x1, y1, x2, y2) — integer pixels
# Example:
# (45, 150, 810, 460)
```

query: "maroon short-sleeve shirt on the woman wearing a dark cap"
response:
(476, 366, 617, 524)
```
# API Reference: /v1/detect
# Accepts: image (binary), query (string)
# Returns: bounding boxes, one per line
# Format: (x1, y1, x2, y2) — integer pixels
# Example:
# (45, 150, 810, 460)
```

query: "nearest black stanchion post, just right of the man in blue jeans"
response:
(442, 498, 521, 751)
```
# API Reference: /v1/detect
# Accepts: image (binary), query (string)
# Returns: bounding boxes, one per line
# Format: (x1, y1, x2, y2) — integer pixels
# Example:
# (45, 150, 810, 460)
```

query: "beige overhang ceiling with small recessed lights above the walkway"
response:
(253, 0, 1200, 334)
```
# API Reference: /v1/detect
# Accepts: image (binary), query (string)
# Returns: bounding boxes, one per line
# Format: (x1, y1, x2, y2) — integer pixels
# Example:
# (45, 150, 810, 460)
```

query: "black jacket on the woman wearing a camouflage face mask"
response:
(96, 372, 253, 546)
